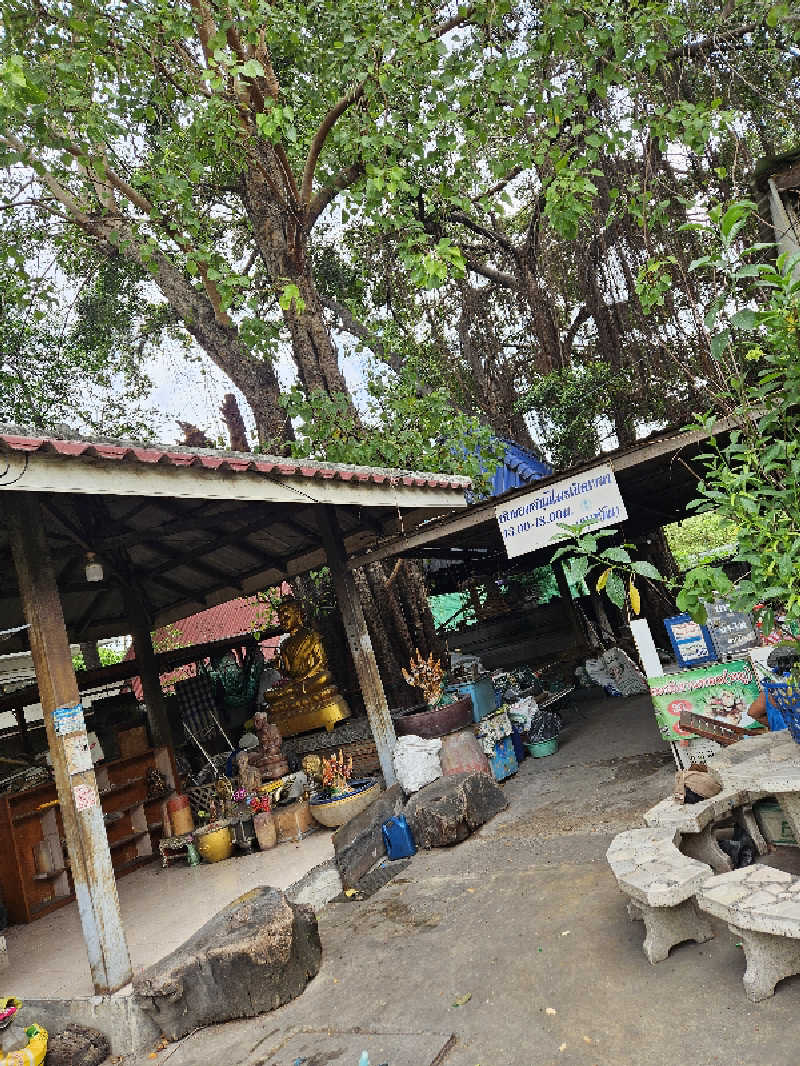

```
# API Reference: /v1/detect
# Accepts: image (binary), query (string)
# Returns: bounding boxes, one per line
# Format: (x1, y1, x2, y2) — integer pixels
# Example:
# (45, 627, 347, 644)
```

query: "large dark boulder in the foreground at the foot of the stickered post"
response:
(133, 884, 322, 1040)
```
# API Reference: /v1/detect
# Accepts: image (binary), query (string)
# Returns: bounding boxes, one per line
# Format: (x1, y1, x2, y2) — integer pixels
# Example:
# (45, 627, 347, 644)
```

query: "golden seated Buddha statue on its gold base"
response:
(265, 600, 350, 737)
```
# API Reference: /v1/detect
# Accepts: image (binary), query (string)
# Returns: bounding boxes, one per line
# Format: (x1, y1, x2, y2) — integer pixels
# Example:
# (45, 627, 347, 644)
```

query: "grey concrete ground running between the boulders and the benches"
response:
(123, 696, 800, 1066)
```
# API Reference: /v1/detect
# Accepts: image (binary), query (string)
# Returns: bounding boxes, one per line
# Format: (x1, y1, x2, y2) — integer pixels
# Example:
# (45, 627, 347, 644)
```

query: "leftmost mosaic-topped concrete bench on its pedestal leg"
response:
(606, 826, 714, 964)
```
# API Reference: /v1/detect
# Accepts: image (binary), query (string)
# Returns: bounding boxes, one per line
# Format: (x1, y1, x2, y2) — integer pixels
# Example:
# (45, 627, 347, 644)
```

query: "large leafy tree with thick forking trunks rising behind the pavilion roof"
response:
(0, 0, 520, 445)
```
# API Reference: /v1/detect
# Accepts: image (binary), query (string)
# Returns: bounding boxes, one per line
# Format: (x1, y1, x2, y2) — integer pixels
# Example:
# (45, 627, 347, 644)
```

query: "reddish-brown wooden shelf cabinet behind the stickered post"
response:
(0, 747, 175, 922)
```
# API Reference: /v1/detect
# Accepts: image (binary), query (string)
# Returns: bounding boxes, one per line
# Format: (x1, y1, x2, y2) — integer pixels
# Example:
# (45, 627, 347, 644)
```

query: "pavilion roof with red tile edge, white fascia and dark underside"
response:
(0, 427, 469, 651)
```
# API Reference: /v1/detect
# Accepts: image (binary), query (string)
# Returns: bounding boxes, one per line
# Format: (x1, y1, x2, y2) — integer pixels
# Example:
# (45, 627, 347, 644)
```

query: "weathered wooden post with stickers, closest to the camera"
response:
(4, 492, 131, 996)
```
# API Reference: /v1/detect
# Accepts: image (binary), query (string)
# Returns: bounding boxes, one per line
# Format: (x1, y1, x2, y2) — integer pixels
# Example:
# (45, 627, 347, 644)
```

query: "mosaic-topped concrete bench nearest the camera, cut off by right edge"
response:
(697, 863, 800, 1003)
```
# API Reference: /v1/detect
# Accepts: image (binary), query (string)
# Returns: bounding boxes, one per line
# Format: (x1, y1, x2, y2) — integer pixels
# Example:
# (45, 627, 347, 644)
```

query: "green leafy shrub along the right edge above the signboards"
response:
(678, 203, 800, 630)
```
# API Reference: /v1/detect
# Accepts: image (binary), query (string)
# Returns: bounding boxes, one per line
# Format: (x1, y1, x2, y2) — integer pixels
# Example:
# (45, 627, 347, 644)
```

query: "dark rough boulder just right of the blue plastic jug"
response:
(405, 774, 508, 847)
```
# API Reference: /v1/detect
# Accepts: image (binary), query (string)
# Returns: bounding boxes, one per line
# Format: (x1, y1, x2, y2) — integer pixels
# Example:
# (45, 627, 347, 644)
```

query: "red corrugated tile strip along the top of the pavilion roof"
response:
(0, 430, 469, 488)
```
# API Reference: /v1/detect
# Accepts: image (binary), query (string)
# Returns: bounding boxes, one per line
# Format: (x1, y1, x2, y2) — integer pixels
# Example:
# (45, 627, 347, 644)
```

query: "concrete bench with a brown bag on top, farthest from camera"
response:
(644, 788, 769, 873)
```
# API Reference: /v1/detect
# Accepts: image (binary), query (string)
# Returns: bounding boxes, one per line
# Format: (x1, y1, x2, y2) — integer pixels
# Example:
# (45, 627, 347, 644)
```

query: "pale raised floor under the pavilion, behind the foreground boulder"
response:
(3, 829, 333, 1000)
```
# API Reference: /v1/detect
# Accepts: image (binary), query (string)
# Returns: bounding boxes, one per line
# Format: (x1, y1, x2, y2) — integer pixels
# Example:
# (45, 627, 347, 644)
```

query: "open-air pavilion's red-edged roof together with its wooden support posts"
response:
(0, 429, 469, 994)
